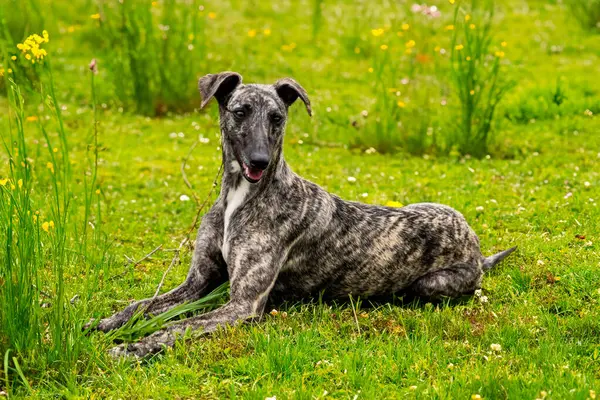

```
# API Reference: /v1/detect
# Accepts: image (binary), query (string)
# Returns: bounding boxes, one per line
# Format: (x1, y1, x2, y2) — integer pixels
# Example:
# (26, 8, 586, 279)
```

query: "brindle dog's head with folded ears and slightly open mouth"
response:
(198, 72, 312, 183)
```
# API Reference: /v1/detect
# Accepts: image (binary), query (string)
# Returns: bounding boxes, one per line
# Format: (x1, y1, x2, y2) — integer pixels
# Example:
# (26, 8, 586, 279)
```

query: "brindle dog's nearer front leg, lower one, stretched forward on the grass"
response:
(111, 243, 281, 357)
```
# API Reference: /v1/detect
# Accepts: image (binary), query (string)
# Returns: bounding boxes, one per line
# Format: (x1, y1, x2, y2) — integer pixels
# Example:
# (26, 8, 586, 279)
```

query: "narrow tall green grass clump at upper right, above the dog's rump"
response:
(446, 0, 513, 157)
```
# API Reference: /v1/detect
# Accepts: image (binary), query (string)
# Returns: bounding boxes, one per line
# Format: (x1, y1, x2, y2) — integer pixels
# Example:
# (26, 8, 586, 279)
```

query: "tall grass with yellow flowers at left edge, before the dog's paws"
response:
(0, 33, 107, 391)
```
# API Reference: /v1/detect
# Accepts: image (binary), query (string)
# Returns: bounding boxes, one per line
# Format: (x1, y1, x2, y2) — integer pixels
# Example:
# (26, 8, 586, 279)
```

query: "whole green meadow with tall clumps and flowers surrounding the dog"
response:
(0, 0, 600, 399)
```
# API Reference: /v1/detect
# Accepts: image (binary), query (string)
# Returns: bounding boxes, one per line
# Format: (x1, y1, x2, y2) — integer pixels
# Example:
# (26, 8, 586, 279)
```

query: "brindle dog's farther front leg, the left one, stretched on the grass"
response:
(88, 207, 227, 332)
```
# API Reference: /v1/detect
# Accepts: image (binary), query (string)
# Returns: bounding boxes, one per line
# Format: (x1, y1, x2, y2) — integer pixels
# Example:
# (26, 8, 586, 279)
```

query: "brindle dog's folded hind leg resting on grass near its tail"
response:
(405, 264, 483, 299)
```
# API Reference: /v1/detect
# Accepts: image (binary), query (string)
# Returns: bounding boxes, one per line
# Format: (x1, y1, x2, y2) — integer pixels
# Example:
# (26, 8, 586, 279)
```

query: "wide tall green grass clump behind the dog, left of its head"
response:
(93, 0, 207, 116)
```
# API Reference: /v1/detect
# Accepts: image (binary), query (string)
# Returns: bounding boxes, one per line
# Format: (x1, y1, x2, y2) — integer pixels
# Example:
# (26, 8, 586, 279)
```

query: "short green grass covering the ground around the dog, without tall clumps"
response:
(0, 0, 600, 399)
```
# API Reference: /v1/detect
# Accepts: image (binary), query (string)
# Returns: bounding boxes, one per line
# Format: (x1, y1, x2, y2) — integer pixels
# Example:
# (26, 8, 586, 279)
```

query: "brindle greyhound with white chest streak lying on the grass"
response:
(96, 72, 514, 356)
